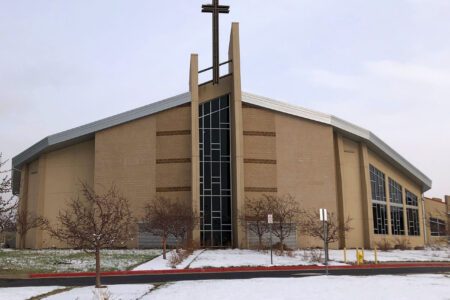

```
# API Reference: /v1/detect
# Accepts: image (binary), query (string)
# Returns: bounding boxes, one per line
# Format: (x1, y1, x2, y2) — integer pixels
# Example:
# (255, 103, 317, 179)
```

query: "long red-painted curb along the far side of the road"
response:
(28, 263, 450, 279)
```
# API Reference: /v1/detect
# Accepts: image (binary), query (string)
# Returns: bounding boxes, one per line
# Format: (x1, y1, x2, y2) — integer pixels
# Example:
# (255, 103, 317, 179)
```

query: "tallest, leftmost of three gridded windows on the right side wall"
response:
(369, 165, 388, 234)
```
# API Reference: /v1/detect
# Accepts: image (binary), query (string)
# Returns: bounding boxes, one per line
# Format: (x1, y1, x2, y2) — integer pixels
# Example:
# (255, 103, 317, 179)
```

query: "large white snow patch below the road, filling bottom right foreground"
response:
(142, 275, 450, 300)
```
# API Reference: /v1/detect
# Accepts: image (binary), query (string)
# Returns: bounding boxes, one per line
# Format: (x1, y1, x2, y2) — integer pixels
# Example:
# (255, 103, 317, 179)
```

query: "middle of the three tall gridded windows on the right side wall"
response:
(389, 178, 405, 235)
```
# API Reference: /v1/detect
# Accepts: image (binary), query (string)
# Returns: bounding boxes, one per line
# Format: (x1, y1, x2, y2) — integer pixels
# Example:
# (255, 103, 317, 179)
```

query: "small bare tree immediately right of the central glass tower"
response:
(239, 196, 270, 250)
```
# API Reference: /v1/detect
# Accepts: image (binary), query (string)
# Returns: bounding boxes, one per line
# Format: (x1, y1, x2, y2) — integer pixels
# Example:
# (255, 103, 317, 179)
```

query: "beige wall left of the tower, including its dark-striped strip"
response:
(95, 105, 191, 247)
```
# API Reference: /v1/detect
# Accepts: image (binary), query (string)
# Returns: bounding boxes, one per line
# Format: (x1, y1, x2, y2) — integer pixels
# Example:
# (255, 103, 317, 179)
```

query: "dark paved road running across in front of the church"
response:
(0, 266, 450, 287)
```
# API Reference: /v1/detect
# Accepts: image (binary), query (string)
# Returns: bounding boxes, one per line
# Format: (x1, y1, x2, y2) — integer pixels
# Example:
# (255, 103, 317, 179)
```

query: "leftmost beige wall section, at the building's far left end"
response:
(22, 140, 94, 248)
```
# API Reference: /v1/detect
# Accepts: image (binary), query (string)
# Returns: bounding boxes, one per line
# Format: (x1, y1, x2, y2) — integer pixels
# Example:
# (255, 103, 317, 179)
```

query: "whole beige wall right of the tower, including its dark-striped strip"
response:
(243, 105, 337, 247)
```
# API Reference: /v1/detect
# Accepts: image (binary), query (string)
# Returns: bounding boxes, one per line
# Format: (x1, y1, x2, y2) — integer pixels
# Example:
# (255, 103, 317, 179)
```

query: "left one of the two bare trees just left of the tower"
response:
(142, 197, 173, 259)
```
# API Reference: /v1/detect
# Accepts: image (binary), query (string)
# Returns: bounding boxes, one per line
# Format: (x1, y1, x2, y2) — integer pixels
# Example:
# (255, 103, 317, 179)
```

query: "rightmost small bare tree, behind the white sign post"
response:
(300, 209, 352, 243)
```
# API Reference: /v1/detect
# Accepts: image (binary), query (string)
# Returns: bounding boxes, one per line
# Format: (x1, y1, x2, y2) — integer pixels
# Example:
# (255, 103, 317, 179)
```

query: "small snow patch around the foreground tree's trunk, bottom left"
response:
(44, 284, 153, 300)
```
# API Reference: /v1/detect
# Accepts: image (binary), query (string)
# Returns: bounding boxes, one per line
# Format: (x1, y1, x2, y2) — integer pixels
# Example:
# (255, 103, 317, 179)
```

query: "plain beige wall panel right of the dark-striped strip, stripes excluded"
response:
(275, 113, 337, 247)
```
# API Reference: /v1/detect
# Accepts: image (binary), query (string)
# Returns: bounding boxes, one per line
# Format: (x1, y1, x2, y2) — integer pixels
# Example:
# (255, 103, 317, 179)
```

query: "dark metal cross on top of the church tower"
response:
(202, 0, 230, 84)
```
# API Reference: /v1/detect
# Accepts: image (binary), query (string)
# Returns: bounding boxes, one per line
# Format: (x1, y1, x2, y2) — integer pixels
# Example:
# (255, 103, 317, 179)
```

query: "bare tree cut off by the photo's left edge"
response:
(0, 153, 18, 233)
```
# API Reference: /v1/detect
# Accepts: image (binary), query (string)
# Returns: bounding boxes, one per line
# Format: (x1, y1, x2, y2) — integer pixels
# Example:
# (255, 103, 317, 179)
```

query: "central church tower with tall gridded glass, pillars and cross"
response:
(189, 0, 245, 247)
